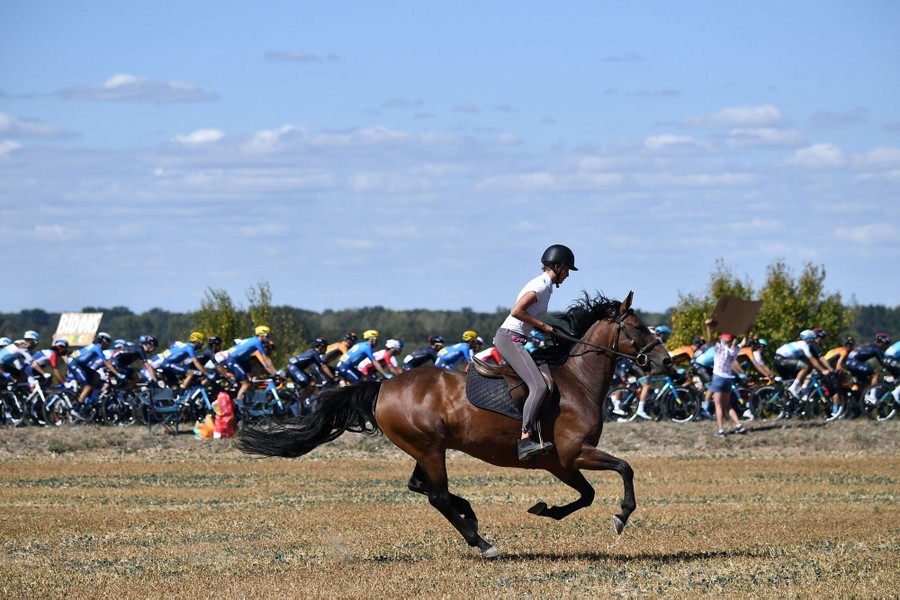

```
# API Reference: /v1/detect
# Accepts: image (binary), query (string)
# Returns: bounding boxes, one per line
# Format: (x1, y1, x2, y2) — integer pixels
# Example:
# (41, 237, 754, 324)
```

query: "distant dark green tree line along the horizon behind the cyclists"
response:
(0, 261, 900, 366)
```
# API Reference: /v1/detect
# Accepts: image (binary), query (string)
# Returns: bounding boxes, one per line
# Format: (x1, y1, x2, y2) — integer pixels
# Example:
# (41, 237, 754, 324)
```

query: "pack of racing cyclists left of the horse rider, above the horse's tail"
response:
(0, 325, 492, 424)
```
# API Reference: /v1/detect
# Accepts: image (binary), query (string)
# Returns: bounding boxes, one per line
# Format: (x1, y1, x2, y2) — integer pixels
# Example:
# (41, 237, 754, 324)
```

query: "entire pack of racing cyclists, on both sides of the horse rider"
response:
(0, 308, 900, 428)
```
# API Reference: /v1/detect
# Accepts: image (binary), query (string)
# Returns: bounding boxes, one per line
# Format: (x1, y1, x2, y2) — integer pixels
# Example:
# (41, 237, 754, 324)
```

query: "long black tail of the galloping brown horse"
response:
(235, 381, 381, 458)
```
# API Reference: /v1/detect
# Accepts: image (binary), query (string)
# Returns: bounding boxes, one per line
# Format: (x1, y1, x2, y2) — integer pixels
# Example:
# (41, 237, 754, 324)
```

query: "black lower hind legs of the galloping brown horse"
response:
(407, 461, 500, 558)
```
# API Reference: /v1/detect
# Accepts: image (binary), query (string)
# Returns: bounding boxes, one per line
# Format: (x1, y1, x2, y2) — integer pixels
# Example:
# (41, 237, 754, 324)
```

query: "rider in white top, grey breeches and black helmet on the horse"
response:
(492, 244, 578, 460)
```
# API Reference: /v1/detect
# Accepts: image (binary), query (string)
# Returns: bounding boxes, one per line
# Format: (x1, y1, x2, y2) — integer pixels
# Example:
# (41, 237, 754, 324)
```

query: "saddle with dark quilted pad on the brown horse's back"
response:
(466, 357, 556, 420)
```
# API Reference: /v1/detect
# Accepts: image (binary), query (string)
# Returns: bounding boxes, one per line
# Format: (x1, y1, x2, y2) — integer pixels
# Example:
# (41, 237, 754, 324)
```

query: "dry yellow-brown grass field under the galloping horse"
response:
(0, 422, 900, 599)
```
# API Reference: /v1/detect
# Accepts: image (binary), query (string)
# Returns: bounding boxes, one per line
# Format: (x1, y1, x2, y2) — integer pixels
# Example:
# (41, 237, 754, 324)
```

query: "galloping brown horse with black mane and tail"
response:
(237, 293, 671, 558)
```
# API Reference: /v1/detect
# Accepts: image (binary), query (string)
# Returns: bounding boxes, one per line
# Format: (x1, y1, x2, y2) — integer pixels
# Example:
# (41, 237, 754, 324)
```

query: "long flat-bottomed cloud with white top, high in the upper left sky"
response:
(56, 73, 219, 104)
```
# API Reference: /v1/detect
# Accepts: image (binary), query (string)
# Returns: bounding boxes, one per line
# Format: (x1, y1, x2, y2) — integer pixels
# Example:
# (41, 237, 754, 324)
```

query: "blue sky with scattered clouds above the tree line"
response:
(0, 0, 900, 312)
